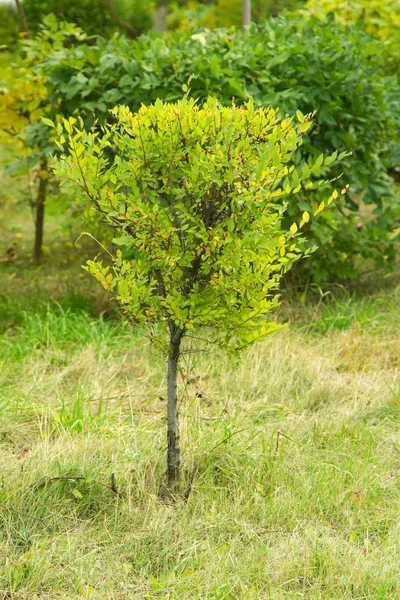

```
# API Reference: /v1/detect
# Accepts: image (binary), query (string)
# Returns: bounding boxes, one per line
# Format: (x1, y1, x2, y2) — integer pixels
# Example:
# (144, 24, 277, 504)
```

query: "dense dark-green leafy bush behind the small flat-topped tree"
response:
(40, 16, 400, 281)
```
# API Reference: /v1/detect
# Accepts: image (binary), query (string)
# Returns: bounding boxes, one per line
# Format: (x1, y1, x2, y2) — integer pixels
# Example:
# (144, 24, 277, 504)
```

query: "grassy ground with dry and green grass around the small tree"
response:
(0, 176, 400, 600)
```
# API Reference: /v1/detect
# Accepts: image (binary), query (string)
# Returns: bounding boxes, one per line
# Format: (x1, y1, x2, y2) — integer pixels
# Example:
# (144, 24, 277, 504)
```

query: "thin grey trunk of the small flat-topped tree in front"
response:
(167, 324, 183, 485)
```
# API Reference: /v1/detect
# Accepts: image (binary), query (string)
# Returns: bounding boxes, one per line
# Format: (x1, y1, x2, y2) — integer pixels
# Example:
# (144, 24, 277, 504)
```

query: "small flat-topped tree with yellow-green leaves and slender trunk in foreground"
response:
(49, 97, 344, 484)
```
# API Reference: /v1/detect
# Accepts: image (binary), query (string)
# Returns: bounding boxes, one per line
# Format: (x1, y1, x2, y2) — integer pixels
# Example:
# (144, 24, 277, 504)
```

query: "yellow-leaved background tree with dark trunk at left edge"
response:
(0, 16, 86, 262)
